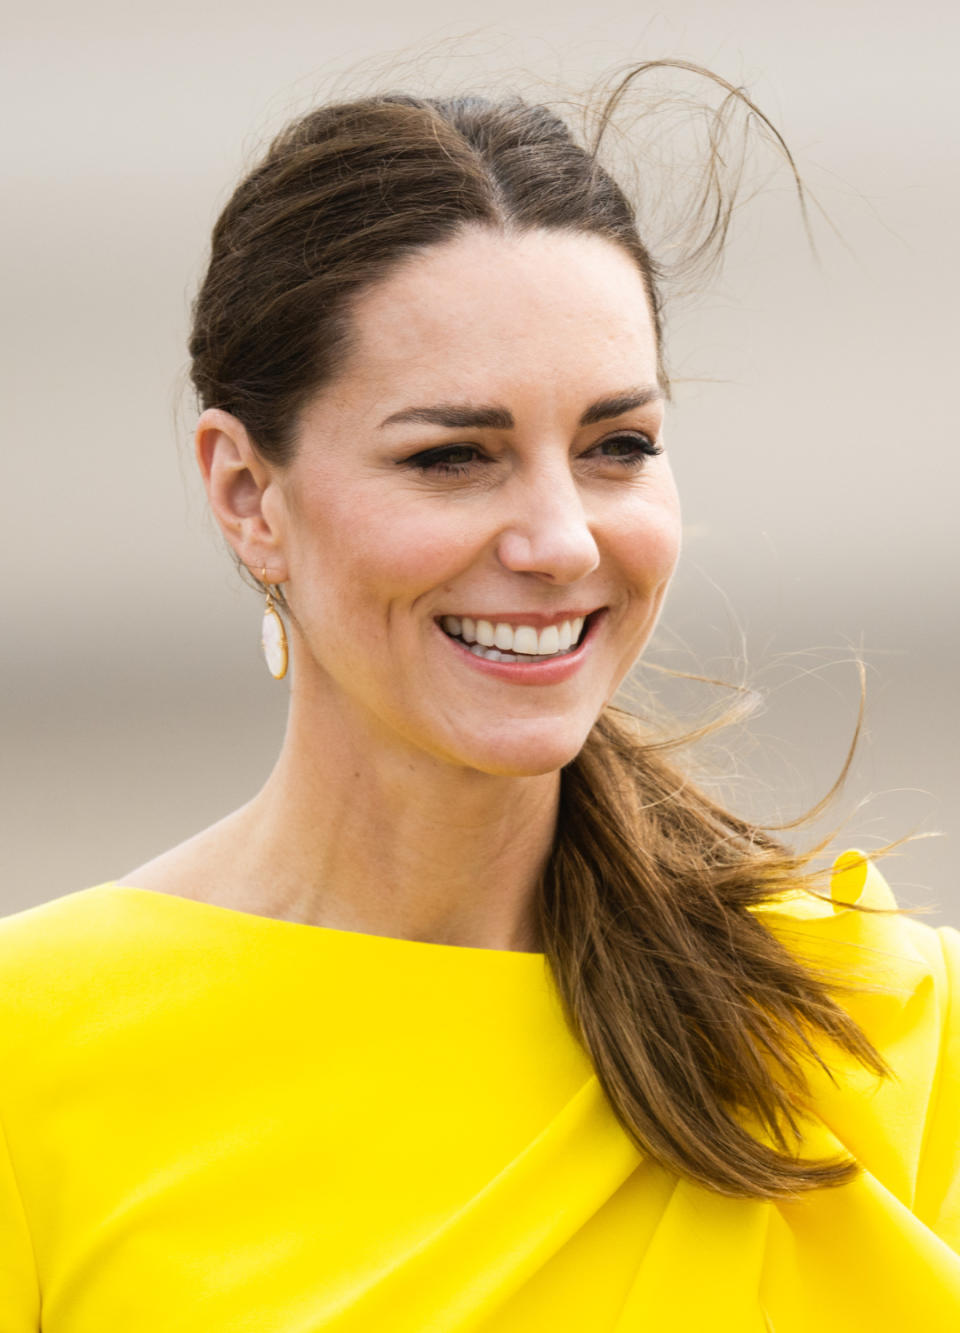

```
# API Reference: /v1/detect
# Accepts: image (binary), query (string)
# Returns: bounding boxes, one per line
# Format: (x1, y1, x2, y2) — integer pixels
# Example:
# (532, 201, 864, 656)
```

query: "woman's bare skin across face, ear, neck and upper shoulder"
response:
(123, 228, 680, 949)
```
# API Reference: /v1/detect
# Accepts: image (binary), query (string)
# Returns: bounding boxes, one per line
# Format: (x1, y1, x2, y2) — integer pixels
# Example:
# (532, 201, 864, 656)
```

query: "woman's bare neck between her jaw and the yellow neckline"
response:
(227, 692, 560, 950)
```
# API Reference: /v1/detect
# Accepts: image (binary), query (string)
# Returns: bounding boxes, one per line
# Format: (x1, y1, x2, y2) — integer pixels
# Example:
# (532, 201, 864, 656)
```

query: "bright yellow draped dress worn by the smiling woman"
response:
(0, 858, 960, 1333)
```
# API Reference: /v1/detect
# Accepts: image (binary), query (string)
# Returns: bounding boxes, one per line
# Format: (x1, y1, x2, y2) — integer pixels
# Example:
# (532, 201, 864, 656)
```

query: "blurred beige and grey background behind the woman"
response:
(0, 0, 960, 925)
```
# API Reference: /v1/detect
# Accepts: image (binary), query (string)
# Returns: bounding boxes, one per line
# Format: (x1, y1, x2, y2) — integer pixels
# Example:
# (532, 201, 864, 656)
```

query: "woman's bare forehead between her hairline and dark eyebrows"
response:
(332, 228, 657, 410)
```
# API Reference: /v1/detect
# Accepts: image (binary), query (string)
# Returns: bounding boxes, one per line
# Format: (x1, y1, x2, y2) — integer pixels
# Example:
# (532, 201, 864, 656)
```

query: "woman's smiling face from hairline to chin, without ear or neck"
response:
(264, 228, 680, 776)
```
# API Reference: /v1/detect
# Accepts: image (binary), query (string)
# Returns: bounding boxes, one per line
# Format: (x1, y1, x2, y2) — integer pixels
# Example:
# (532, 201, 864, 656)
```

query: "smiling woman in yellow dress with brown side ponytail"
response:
(0, 59, 960, 1333)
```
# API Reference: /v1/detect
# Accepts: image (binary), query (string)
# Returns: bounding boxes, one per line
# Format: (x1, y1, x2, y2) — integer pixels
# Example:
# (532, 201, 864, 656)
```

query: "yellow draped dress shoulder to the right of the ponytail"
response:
(761, 852, 960, 1226)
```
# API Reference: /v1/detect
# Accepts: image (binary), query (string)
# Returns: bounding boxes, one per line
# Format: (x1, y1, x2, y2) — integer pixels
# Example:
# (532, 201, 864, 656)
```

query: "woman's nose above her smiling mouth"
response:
(497, 468, 600, 584)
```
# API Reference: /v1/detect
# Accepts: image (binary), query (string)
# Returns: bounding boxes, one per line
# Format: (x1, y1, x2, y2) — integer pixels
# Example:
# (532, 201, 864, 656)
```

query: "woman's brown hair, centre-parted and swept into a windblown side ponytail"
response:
(189, 61, 888, 1198)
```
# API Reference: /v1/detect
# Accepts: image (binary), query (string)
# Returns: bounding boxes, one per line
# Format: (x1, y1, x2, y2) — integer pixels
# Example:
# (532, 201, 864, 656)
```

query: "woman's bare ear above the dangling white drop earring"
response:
(196, 408, 288, 584)
